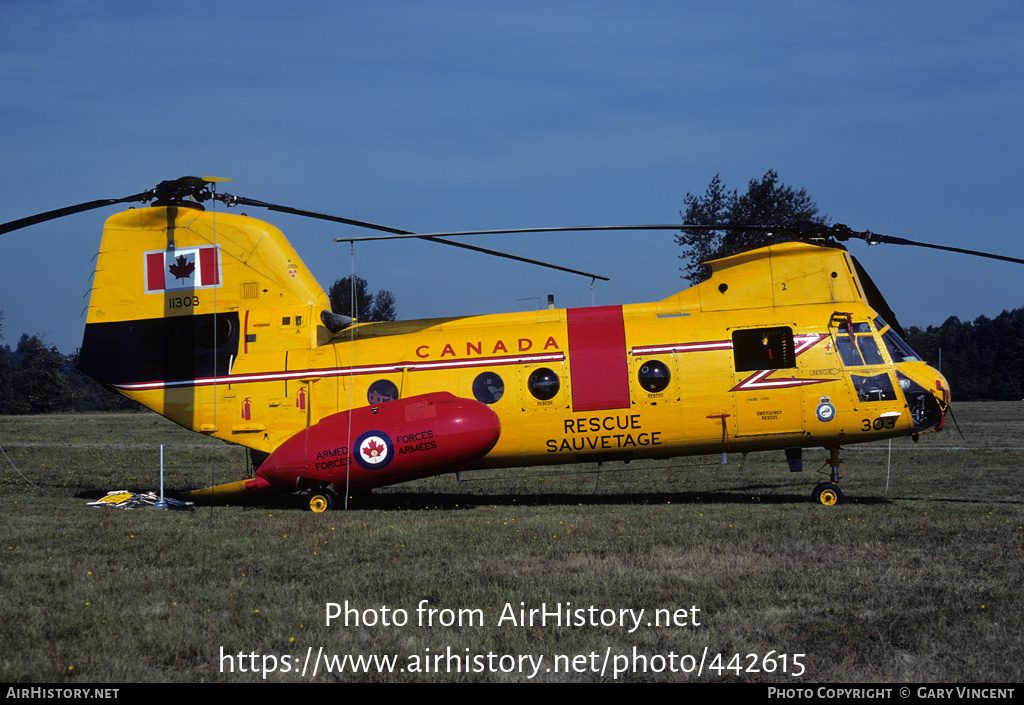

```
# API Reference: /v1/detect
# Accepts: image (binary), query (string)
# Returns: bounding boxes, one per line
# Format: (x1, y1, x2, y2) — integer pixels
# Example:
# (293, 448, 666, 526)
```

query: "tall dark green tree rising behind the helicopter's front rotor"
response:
(676, 170, 828, 284)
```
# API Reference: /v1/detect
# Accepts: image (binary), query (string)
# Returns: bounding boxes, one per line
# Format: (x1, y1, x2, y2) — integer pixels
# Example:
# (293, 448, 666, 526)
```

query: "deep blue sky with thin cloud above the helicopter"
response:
(0, 0, 1024, 353)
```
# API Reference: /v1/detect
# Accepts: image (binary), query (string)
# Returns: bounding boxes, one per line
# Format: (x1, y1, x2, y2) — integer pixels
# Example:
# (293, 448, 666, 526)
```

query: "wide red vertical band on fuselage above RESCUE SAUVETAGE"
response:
(565, 306, 630, 411)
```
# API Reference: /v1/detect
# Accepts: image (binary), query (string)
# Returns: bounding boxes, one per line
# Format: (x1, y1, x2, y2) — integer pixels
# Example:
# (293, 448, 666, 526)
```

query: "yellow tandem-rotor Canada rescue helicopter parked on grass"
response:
(0, 176, 1024, 511)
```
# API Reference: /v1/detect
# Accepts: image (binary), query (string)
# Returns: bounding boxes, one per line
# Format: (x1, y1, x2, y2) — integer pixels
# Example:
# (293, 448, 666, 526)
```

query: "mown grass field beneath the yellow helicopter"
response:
(0, 403, 1024, 686)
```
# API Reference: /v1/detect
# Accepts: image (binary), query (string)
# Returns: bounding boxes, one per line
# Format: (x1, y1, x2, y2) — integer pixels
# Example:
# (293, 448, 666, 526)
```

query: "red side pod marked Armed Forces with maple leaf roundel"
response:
(256, 391, 501, 492)
